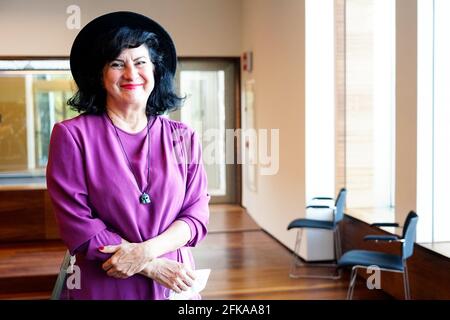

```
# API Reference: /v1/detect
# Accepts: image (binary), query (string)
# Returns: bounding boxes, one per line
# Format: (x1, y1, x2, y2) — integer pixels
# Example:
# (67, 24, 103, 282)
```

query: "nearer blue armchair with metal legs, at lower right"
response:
(338, 211, 419, 300)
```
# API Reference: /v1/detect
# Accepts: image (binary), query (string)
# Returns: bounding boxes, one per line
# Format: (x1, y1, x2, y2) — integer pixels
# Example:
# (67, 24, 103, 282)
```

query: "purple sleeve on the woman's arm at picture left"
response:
(46, 124, 121, 260)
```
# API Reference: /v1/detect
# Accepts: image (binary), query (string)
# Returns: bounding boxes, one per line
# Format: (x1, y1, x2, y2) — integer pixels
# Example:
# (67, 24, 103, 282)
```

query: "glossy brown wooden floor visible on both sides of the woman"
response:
(0, 205, 390, 300)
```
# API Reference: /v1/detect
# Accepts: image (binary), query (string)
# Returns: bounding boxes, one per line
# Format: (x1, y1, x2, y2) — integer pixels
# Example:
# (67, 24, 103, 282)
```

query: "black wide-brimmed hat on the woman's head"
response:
(70, 11, 177, 85)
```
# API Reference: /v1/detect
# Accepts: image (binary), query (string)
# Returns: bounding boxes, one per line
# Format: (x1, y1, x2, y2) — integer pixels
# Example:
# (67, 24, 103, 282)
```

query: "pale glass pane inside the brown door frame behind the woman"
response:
(180, 70, 226, 196)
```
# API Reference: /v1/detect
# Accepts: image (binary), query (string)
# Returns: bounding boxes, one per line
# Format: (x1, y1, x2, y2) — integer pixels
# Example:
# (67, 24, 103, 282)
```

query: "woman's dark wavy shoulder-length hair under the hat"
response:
(67, 27, 185, 116)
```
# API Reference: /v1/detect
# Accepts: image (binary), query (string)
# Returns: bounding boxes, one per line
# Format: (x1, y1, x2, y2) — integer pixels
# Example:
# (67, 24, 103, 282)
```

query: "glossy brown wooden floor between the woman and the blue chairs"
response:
(193, 205, 391, 300)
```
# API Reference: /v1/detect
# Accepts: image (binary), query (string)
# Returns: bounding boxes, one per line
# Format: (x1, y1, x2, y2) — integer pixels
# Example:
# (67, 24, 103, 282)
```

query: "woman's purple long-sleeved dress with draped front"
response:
(47, 114, 210, 299)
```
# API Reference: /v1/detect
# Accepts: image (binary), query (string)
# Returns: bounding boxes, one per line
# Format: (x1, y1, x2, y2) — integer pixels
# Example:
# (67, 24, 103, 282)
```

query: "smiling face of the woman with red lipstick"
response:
(103, 45, 155, 108)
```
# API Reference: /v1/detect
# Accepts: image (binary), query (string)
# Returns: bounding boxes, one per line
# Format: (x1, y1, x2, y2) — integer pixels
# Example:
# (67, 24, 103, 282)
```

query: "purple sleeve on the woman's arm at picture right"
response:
(177, 132, 210, 247)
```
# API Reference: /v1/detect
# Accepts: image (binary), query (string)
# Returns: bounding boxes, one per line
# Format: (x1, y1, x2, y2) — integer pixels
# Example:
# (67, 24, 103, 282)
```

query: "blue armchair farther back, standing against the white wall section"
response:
(287, 188, 347, 279)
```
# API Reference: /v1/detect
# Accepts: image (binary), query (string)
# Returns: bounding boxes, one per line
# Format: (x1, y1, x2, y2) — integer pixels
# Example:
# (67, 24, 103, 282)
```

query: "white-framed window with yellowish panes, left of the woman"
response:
(0, 60, 77, 184)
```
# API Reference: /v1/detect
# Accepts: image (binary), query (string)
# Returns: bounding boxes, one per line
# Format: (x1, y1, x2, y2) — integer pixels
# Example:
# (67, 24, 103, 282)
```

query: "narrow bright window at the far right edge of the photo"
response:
(417, 0, 450, 242)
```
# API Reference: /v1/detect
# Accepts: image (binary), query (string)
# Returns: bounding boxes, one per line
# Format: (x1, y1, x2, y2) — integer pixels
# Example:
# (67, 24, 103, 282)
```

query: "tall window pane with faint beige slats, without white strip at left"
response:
(344, 0, 395, 209)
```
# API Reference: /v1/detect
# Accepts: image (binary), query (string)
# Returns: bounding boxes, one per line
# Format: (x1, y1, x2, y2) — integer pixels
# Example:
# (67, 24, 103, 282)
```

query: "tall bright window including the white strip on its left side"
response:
(305, 0, 395, 210)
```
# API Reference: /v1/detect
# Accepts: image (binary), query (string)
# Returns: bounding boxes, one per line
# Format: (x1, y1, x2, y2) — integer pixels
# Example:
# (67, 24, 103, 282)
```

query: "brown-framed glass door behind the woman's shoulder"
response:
(170, 59, 240, 203)
